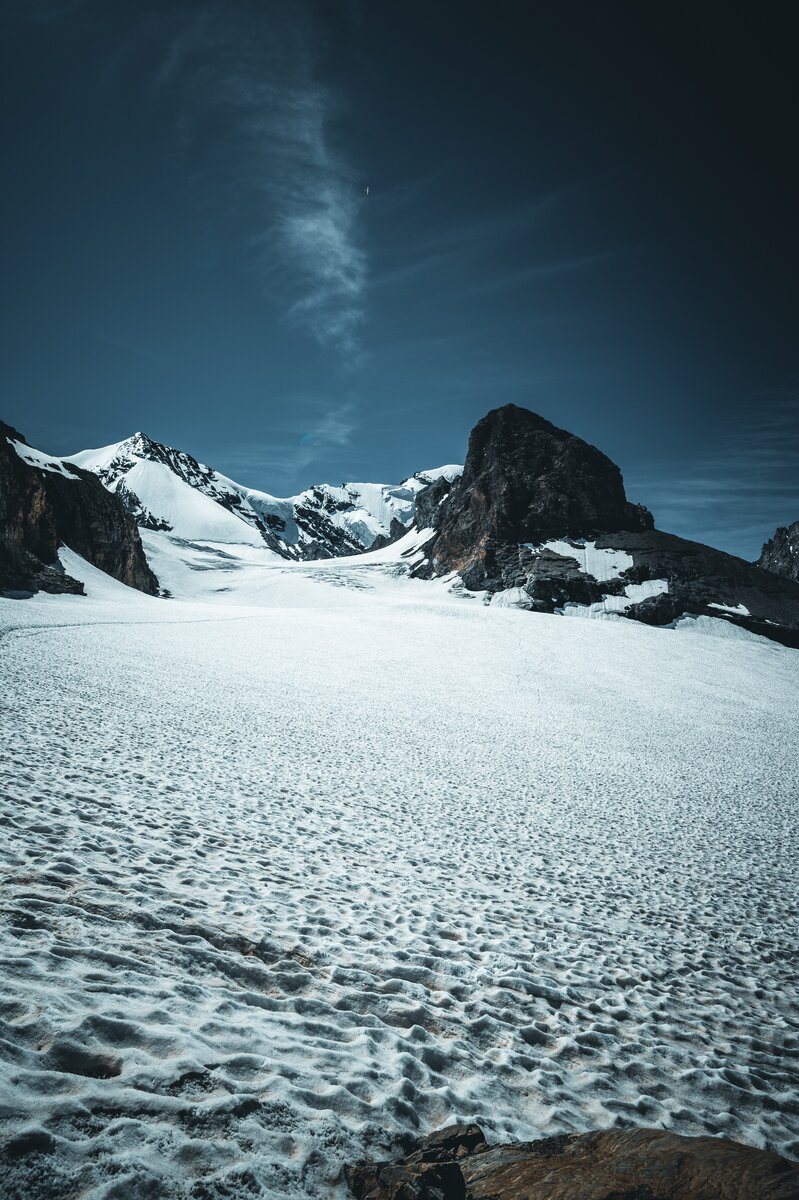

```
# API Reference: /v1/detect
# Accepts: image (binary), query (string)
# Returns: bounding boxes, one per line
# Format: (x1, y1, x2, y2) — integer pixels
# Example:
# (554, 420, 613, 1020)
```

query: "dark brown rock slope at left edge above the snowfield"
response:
(0, 421, 158, 595)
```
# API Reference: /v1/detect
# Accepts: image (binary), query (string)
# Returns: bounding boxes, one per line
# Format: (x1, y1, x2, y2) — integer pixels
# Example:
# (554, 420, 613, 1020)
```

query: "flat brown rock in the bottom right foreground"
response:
(346, 1126, 799, 1200)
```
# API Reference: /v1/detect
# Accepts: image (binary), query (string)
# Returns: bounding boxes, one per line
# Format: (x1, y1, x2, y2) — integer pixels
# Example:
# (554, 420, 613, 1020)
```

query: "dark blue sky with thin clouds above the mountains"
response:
(0, 0, 799, 558)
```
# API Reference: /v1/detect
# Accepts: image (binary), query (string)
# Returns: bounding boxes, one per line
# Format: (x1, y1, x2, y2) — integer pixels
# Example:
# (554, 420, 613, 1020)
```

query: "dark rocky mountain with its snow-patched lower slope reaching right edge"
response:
(414, 404, 799, 646)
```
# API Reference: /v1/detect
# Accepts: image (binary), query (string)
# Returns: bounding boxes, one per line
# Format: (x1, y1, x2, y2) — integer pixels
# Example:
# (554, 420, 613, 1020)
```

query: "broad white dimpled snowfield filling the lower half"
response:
(0, 540, 799, 1200)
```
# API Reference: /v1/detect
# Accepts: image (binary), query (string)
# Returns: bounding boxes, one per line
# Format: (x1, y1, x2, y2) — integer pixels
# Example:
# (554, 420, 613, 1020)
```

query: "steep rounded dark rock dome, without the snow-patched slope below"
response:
(434, 404, 654, 587)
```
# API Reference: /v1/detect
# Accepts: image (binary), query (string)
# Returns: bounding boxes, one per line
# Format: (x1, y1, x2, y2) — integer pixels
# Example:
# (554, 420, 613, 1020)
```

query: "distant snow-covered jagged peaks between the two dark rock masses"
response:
(70, 433, 461, 559)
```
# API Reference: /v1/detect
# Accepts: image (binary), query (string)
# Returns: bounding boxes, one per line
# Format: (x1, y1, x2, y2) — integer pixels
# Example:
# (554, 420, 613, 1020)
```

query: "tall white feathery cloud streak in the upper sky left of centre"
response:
(160, 0, 367, 367)
